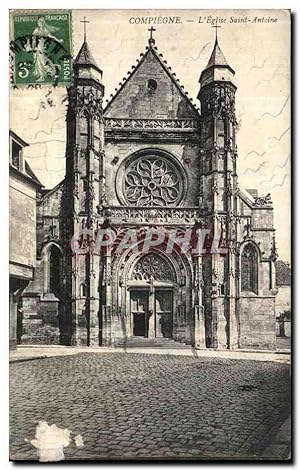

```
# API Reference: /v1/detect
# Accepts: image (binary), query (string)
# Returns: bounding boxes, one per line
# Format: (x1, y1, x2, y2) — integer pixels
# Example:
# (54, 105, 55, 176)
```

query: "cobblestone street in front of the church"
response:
(10, 353, 290, 460)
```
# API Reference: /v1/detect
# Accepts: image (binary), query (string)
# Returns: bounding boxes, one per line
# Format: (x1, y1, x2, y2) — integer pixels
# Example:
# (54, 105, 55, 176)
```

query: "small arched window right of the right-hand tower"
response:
(241, 244, 258, 294)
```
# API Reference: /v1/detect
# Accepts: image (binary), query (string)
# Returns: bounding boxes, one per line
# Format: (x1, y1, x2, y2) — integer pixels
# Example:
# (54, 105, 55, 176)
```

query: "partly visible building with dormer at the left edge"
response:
(9, 131, 42, 348)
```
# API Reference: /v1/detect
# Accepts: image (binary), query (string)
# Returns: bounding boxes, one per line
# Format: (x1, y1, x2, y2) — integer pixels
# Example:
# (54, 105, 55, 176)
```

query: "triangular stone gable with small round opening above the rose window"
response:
(104, 47, 199, 119)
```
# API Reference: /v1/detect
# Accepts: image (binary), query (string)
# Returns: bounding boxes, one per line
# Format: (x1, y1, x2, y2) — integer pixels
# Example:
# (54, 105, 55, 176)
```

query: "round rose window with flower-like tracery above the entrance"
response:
(124, 156, 183, 206)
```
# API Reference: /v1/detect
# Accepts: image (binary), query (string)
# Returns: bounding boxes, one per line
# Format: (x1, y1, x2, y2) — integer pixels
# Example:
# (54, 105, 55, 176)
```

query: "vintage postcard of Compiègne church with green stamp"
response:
(9, 9, 292, 462)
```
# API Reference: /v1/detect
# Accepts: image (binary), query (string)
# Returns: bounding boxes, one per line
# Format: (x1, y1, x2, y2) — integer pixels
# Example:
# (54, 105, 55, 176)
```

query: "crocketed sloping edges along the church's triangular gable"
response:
(103, 46, 200, 117)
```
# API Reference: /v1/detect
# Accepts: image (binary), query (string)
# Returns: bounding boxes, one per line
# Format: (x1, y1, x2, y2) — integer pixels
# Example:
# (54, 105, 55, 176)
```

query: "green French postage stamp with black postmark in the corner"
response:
(10, 11, 72, 86)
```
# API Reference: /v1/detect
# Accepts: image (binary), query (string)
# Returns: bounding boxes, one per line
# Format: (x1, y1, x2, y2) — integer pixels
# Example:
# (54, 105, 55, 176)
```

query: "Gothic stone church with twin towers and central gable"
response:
(19, 27, 276, 349)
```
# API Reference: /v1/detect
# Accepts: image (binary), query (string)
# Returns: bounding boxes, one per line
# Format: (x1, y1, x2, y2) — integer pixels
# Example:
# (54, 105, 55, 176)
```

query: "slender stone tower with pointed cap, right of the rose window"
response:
(198, 38, 238, 348)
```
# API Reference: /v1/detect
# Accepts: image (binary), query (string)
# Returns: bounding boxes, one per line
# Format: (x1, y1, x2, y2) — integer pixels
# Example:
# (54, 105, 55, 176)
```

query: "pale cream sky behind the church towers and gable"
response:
(10, 10, 291, 261)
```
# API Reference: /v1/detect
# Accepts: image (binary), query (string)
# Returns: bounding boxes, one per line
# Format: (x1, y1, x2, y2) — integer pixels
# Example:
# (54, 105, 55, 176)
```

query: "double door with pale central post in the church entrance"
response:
(130, 288, 173, 338)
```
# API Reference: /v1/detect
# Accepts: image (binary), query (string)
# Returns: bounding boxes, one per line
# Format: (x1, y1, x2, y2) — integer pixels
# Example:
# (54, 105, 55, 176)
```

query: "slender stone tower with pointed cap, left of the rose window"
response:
(62, 40, 104, 345)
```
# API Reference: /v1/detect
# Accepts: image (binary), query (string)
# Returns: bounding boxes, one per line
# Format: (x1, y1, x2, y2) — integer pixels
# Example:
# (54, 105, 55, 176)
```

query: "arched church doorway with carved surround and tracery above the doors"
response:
(108, 235, 194, 343)
